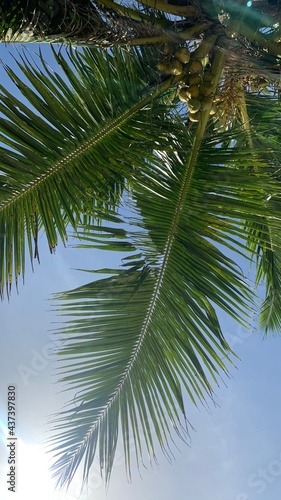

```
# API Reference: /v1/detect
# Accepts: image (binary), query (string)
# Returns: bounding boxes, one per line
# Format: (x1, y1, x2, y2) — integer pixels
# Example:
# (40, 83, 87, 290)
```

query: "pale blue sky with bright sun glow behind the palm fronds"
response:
(0, 44, 281, 500)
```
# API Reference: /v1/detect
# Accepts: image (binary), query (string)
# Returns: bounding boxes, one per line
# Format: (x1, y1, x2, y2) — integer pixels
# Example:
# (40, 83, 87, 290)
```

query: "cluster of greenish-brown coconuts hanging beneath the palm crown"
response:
(157, 47, 219, 122)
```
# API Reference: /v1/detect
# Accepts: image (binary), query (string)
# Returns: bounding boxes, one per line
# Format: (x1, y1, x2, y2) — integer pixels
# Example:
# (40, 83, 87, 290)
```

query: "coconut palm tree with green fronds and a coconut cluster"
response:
(0, 2, 281, 492)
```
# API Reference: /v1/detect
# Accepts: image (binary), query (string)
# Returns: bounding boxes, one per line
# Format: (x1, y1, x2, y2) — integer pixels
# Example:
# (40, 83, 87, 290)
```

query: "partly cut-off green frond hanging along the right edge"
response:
(230, 89, 281, 334)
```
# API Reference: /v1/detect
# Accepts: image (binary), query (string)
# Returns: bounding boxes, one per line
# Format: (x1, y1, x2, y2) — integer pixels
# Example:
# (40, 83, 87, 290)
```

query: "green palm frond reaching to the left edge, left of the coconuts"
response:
(0, 45, 173, 295)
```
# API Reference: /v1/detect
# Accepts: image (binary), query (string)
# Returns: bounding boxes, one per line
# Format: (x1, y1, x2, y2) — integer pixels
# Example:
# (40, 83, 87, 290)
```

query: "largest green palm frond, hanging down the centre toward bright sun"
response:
(47, 112, 280, 486)
